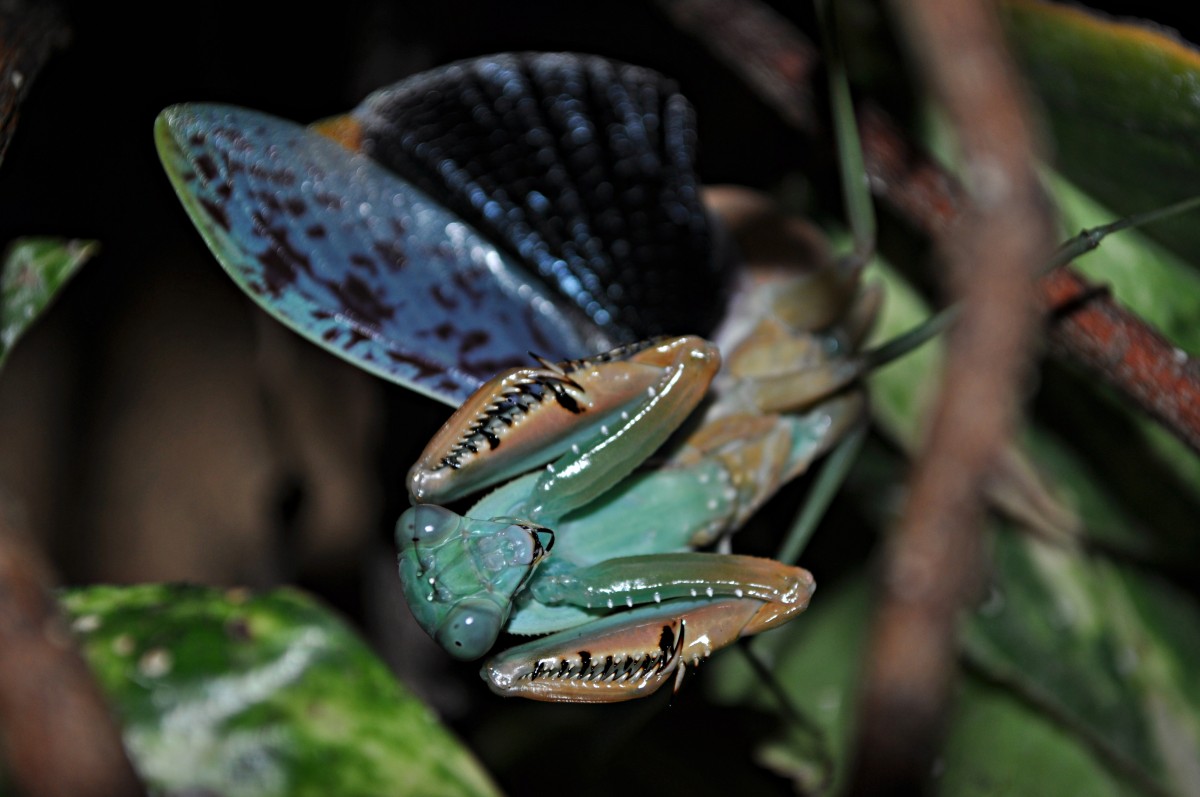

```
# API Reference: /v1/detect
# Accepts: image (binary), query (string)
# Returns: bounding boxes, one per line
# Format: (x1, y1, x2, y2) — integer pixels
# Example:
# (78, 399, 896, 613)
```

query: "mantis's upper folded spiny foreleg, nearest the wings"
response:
(408, 335, 720, 506)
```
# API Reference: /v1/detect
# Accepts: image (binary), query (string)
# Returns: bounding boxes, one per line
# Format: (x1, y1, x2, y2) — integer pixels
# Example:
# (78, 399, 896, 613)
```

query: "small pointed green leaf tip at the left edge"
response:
(0, 238, 100, 366)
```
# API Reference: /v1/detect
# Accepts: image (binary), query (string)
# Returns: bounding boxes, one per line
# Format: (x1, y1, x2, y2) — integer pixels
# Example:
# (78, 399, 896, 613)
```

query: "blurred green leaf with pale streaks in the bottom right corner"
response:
(964, 533, 1200, 793)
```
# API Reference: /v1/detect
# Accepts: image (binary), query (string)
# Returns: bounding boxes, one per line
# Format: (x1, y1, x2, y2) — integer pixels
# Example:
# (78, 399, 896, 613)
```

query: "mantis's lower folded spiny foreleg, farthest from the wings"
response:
(481, 553, 815, 702)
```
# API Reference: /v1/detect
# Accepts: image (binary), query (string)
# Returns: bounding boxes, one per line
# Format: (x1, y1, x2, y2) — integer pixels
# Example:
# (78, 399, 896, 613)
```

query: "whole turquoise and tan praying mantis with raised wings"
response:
(156, 54, 878, 702)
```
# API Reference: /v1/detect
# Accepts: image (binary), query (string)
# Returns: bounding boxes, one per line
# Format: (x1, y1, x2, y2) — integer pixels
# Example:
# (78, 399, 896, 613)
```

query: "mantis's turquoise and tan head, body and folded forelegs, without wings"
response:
(397, 226, 871, 702)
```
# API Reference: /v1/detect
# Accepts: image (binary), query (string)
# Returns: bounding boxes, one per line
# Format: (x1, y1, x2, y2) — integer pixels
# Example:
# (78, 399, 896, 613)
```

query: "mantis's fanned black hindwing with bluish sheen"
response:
(353, 53, 730, 338)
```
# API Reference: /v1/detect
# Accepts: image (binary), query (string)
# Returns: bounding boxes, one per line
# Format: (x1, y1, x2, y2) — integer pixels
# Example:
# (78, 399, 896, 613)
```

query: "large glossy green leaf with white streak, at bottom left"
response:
(62, 585, 498, 797)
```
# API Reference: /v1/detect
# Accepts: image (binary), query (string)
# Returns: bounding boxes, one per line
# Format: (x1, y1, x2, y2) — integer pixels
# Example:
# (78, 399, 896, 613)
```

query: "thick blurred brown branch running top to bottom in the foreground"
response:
(851, 0, 1054, 795)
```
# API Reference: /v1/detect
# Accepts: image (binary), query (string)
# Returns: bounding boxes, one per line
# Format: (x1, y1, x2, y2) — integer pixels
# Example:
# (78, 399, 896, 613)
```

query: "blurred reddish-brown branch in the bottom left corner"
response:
(0, 505, 145, 797)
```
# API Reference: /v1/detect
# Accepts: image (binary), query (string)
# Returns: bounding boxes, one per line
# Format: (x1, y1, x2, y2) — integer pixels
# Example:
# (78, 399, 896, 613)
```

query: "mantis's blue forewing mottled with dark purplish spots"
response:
(156, 104, 608, 405)
